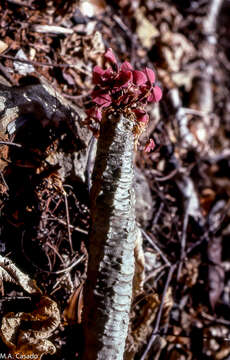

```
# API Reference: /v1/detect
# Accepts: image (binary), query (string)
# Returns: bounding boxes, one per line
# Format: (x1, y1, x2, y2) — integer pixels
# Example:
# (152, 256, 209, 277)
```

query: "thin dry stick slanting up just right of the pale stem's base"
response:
(140, 264, 176, 360)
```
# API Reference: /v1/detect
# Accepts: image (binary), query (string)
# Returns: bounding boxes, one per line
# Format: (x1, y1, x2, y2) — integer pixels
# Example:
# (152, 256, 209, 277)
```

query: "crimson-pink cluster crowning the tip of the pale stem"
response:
(87, 49, 162, 123)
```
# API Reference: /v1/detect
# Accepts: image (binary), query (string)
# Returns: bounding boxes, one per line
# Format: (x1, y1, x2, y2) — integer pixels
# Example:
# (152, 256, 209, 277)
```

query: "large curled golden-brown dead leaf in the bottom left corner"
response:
(0, 296, 60, 359)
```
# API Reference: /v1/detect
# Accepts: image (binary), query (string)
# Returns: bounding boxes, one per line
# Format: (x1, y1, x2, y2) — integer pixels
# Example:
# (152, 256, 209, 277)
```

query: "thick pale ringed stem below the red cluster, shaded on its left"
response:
(83, 114, 137, 360)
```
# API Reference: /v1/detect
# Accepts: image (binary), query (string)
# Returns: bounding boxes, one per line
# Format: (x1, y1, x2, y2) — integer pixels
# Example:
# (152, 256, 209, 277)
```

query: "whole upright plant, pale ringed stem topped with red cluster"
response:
(83, 49, 162, 360)
